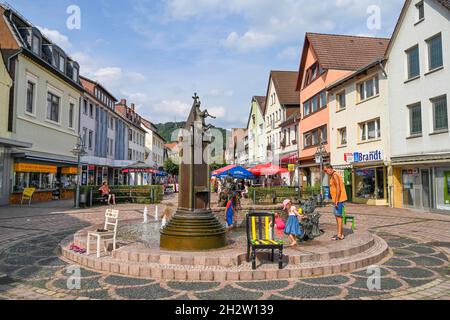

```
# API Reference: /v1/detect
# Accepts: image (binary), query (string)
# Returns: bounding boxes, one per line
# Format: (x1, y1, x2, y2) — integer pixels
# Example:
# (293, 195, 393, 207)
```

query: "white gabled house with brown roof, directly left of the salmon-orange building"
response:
(264, 71, 300, 165)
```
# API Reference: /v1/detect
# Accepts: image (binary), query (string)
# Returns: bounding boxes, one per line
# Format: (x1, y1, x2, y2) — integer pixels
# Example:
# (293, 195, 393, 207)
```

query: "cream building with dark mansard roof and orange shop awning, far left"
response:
(0, 5, 83, 203)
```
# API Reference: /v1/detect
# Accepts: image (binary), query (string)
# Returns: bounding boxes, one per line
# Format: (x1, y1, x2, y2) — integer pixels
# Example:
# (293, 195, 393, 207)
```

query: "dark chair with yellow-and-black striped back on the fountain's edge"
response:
(246, 212, 284, 270)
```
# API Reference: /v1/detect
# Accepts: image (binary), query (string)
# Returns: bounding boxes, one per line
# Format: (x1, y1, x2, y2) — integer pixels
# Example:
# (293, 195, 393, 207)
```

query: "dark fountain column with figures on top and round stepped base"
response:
(160, 94, 227, 251)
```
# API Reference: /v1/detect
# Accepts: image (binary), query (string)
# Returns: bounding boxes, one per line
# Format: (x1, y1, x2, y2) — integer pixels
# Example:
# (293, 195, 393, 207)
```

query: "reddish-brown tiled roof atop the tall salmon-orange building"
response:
(306, 33, 389, 70)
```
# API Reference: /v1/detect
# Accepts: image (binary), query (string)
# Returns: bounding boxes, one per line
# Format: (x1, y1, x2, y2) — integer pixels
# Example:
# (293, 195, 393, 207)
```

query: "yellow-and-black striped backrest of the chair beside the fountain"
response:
(247, 212, 275, 243)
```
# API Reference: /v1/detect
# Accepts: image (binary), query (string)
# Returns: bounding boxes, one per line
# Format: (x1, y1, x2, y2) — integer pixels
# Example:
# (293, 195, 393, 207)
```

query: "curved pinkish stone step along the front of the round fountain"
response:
(61, 235, 389, 281)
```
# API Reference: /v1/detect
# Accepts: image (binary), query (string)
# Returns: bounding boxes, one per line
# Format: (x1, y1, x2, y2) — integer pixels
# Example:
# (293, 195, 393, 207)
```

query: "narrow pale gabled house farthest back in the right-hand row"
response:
(247, 96, 267, 166)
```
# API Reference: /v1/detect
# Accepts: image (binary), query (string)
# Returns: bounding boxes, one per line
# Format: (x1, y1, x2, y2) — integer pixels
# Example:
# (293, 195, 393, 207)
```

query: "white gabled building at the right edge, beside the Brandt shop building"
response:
(386, 0, 450, 212)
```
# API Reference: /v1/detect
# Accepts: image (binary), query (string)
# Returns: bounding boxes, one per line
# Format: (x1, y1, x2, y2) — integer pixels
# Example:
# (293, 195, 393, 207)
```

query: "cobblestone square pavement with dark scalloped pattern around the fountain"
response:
(0, 203, 450, 300)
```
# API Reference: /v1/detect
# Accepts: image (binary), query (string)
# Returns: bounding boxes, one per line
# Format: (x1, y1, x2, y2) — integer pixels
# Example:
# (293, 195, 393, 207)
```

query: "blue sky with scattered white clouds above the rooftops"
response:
(9, 0, 403, 128)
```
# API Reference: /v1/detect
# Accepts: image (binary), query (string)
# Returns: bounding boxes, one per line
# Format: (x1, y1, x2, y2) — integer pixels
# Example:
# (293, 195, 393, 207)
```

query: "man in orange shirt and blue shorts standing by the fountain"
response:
(324, 164, 348, 241)
